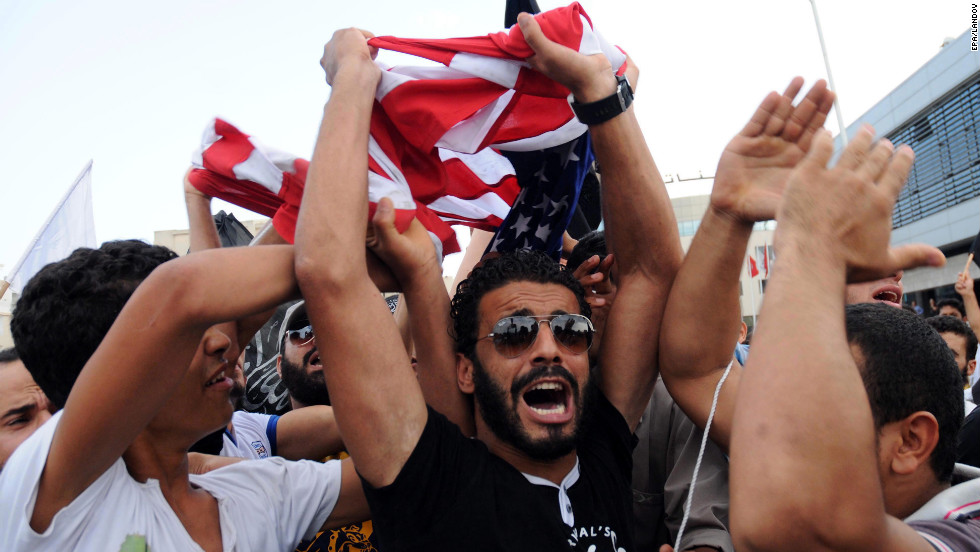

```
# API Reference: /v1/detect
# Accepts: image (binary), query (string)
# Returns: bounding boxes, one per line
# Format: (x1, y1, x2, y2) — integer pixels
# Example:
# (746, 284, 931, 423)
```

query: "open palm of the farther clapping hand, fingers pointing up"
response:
(711, 77, 834, 222)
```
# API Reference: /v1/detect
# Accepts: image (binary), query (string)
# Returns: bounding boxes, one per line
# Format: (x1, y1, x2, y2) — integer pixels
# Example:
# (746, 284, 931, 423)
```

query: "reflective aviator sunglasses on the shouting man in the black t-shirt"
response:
(477, 314, 595, 358)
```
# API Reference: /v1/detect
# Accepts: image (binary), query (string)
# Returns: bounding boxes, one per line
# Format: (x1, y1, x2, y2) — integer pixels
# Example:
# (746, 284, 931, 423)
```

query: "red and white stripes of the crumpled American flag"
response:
(190, 3, 626, 254)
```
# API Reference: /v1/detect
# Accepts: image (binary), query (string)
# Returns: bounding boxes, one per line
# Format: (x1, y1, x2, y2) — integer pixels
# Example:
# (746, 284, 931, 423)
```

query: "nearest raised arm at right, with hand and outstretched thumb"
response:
(731, 128, 944, 551)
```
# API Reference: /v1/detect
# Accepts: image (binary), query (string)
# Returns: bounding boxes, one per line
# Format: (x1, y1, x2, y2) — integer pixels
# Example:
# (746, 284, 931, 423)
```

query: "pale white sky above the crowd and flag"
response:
(0, 0, 970, 276)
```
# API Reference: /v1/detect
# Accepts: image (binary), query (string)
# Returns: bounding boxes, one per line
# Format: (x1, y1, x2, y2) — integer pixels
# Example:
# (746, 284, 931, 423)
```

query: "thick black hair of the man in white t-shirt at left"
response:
(10, 240, 177, 408)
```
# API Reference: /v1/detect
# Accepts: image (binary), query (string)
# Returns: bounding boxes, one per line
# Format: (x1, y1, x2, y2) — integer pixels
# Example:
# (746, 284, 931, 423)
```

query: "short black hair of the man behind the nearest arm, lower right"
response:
(847, 303, 963, 482)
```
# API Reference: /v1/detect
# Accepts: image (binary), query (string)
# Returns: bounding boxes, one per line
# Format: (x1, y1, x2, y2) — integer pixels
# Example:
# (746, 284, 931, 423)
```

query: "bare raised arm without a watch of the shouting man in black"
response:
(296, 29, 428, 487)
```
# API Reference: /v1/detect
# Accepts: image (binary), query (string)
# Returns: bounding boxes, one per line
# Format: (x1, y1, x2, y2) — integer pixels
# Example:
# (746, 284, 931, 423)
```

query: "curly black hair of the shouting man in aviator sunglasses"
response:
(450, 250, 592, 359)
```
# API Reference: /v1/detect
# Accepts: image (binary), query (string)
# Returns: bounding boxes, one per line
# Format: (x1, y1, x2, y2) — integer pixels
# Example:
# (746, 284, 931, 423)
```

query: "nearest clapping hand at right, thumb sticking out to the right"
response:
(776, 127, 946, 282)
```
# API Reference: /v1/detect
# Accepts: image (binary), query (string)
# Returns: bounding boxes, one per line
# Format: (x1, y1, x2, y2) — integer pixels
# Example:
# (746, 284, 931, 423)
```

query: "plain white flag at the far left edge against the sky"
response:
(7, 161, 98, 293)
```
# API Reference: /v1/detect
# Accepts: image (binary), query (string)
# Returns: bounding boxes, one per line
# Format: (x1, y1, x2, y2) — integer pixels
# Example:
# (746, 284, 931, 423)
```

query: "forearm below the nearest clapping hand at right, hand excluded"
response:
(731, 239, 884, 549)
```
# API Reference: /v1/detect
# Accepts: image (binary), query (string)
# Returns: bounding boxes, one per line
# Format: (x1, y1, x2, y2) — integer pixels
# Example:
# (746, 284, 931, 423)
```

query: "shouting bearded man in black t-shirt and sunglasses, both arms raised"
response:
(296, 14, 681, 550)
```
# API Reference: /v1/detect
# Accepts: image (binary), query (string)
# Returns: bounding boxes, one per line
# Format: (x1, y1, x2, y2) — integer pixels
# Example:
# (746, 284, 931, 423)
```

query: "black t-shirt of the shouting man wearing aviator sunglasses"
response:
(363, 396, 636, 552)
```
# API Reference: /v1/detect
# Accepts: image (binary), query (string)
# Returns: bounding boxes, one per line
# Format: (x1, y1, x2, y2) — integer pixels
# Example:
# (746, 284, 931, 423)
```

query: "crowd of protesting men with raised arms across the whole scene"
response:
(0, 8, 980, 552)
